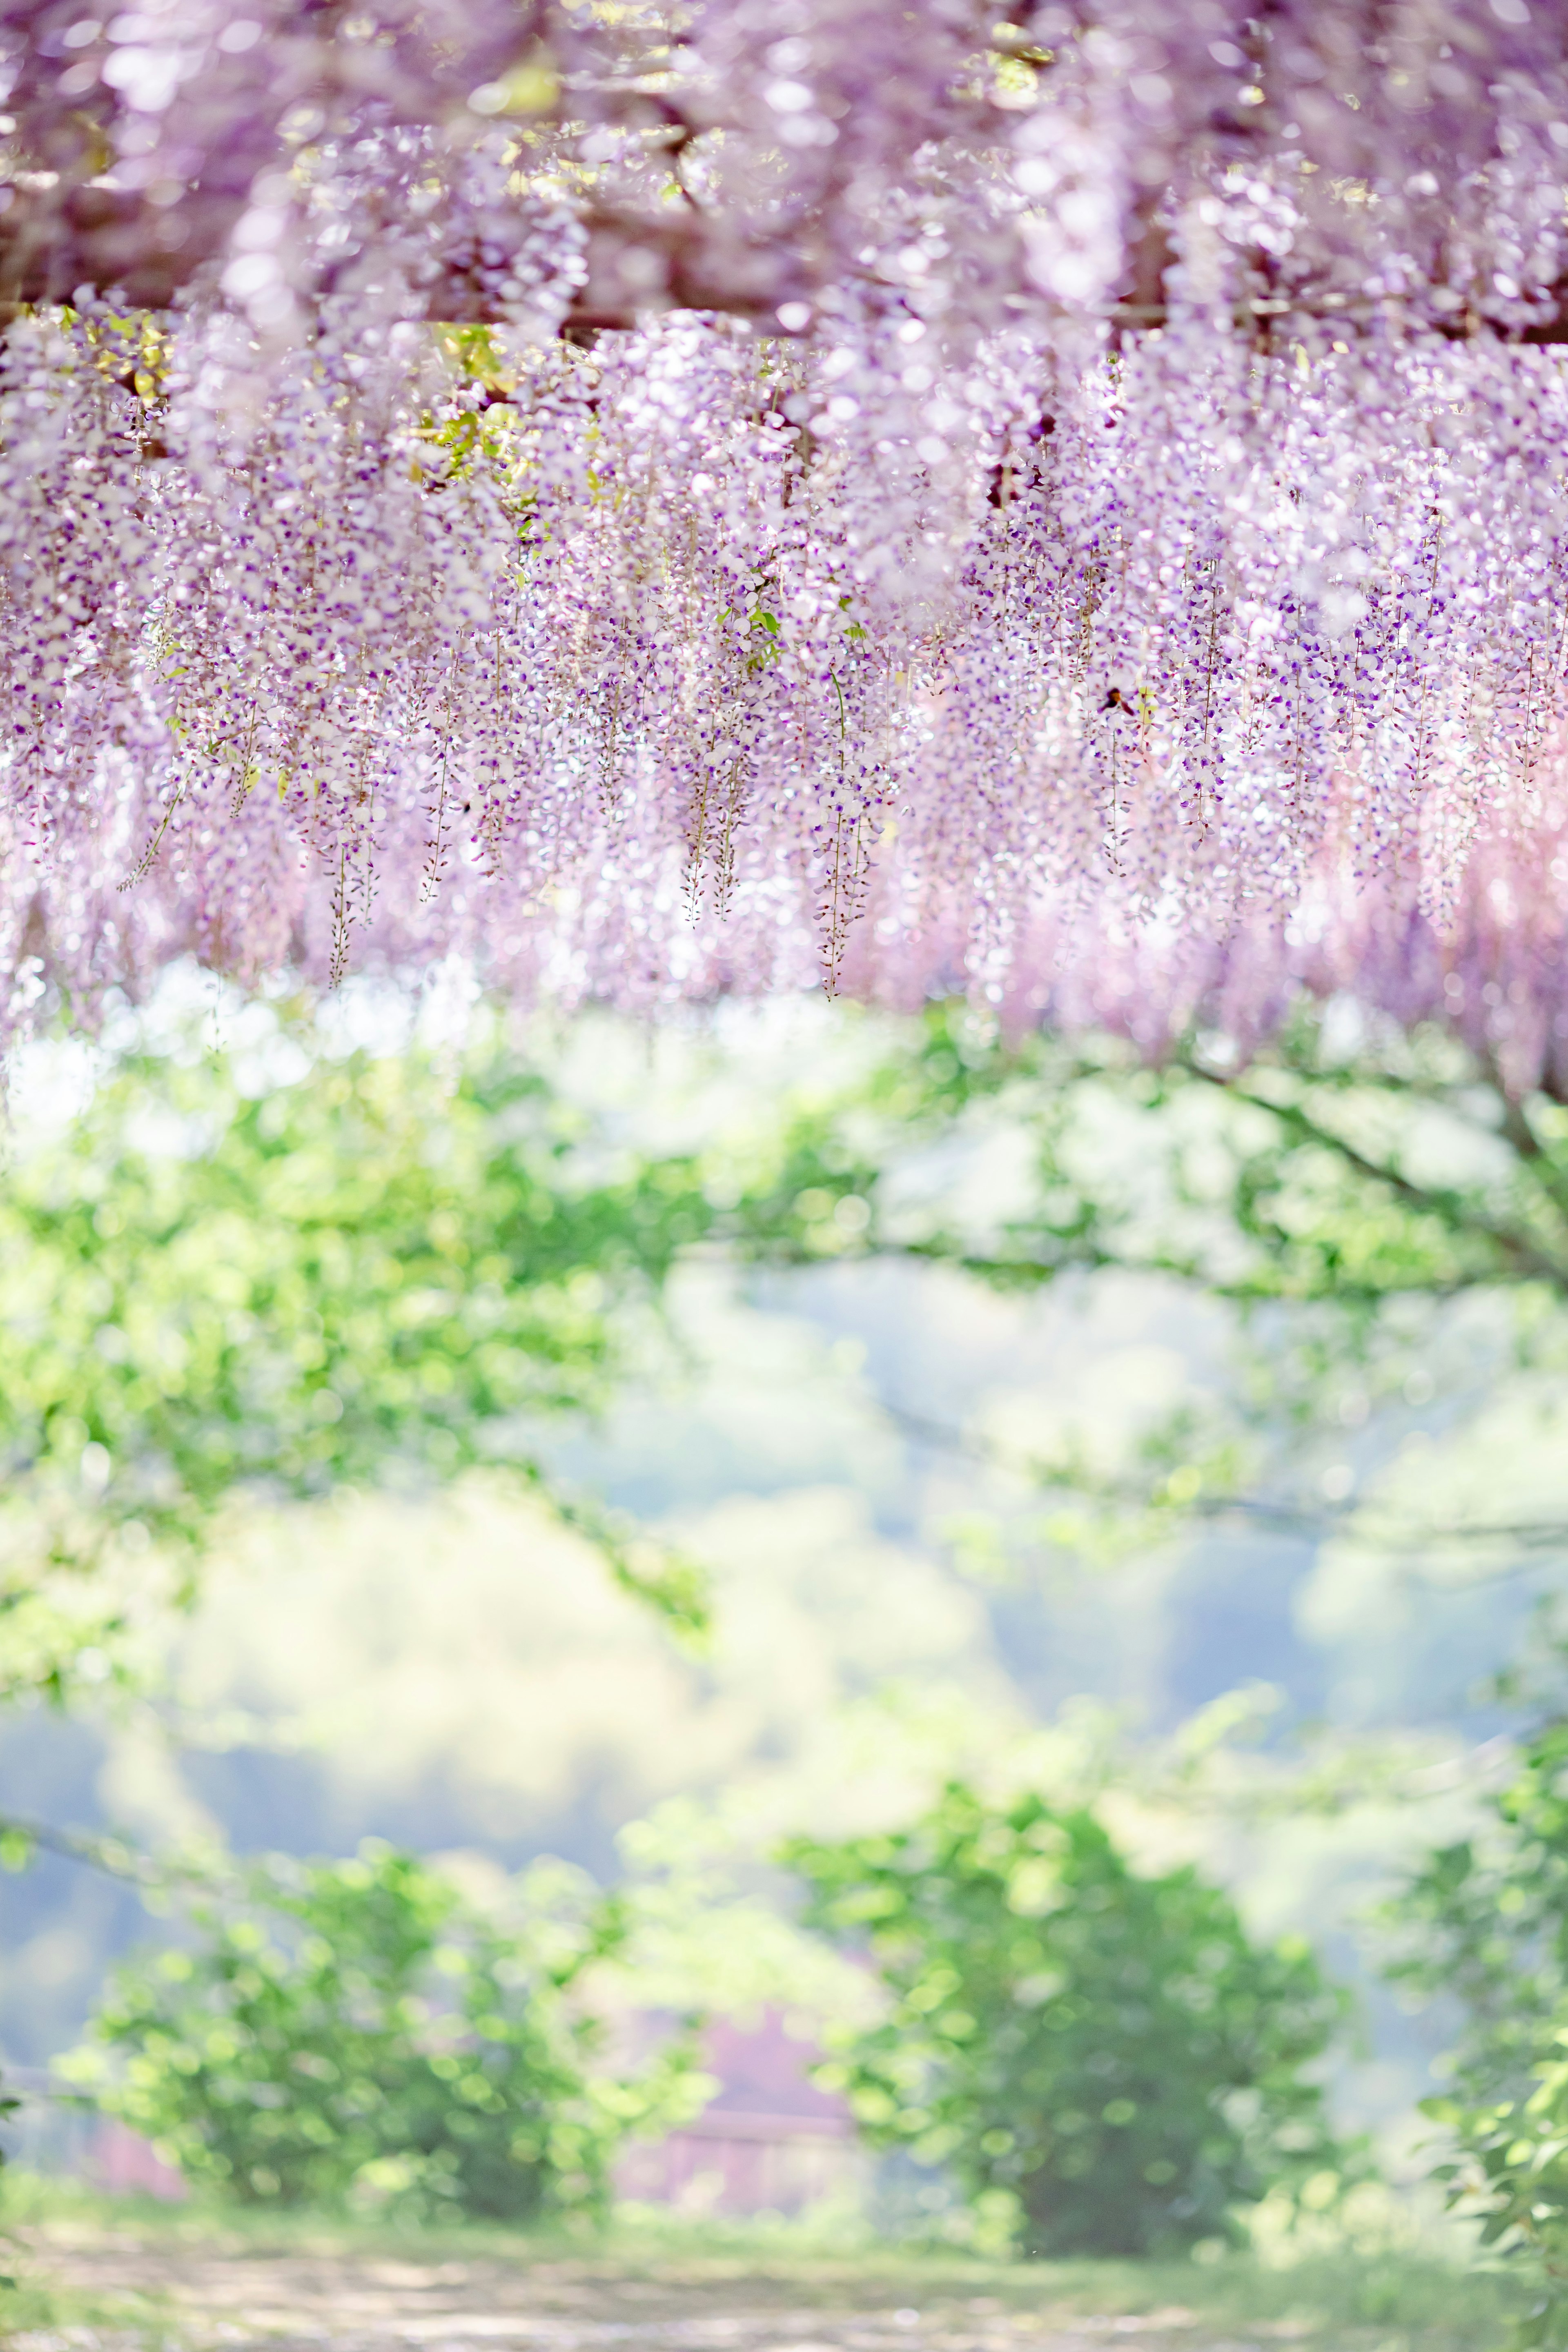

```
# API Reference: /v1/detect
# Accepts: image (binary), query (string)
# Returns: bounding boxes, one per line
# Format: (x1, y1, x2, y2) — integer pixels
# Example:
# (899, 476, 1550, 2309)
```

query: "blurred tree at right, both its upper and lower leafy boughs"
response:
(743, 1002, 1568, 1548)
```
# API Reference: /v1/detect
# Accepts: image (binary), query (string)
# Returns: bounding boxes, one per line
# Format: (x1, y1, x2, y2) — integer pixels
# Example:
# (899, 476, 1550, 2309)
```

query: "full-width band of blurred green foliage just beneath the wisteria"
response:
(12, 1007, 1568, 1698)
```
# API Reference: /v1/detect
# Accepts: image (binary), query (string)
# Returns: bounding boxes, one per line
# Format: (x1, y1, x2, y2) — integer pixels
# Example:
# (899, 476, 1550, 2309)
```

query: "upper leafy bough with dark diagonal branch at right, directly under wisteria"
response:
(846, 1004, 1568, 1310)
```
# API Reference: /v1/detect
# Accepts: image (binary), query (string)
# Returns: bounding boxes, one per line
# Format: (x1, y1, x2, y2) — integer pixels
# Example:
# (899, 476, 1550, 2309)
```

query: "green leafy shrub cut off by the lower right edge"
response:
(1387, 1717, 1568, 2347)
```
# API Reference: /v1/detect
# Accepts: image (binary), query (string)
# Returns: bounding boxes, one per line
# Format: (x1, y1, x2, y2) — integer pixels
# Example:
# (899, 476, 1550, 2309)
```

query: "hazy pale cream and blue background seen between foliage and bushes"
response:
(0, 960, 1568, 2201)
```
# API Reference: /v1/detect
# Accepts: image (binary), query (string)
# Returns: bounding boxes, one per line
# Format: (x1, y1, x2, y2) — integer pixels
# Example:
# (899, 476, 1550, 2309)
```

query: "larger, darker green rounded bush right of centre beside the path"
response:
(785, 1785, 1342, 2253)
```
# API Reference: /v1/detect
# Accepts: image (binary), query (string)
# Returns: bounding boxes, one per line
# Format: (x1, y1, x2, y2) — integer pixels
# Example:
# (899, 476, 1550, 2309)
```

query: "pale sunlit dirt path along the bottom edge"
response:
(7, 2223, 1495, 2352)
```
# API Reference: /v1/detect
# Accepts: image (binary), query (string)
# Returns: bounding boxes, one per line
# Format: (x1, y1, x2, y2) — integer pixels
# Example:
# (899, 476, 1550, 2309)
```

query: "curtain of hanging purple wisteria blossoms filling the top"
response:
(0, 0, 1568, 1087)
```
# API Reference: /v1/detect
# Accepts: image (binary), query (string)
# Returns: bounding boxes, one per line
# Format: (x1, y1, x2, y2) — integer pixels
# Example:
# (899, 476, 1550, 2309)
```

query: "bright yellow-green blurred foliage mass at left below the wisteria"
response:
(0, 1020, 747, 1698)
